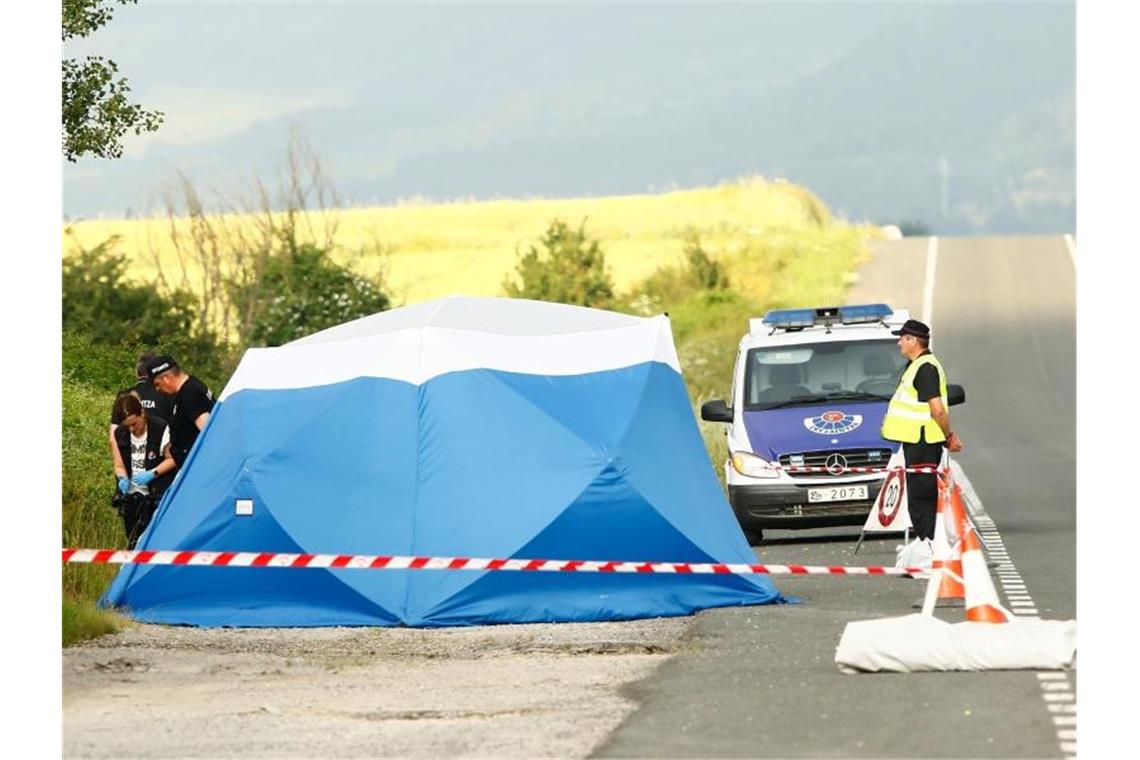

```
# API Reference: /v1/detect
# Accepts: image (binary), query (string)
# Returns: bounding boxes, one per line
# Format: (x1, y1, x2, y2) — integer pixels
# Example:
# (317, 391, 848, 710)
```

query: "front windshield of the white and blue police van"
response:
(744, 341, 906, 410)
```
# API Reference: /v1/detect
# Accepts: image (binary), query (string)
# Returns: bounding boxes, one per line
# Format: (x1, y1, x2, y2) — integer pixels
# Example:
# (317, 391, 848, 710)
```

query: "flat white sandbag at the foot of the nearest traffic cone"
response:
(836, 614, 1076, 673)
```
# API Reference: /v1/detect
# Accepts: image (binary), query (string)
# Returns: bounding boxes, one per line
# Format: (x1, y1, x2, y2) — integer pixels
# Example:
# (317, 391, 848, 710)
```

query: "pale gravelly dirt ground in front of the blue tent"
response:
(63, 618, 692, 758)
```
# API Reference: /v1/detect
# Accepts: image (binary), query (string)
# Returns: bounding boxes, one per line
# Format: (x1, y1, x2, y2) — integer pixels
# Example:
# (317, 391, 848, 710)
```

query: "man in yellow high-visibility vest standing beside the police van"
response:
(881, 319, 962, 539)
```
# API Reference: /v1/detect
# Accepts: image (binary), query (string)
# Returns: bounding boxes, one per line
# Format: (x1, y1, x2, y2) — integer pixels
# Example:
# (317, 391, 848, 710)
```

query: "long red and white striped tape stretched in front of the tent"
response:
(63, 549, 926, 575)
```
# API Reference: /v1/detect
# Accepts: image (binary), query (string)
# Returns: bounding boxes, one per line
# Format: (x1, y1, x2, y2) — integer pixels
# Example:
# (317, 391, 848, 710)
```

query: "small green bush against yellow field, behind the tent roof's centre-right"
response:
(503, 219, 613, 309)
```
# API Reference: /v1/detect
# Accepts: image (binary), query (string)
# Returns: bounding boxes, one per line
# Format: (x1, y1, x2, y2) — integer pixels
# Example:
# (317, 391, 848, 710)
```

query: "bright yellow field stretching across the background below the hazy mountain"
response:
(64, 178, 865, 304)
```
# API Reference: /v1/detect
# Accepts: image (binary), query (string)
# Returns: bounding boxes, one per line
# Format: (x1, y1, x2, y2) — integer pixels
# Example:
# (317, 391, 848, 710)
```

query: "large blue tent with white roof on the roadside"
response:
(101, 296, 783, 627)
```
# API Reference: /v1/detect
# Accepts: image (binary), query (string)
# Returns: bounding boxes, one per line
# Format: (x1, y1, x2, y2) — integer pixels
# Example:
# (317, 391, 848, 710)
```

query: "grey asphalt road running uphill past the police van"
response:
(596, 236, 1076, 758)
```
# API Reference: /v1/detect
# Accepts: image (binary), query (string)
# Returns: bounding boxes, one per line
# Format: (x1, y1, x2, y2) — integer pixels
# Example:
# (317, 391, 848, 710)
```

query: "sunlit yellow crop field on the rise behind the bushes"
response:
(64, 178, 879, 303)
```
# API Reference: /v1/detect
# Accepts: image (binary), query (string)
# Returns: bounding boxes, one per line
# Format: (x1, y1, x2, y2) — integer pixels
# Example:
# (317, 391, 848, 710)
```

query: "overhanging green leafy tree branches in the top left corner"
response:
(63, 0, 163, 162)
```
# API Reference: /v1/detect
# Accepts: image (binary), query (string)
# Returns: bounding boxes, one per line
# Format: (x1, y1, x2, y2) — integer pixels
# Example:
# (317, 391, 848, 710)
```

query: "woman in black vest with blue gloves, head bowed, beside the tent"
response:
(112, 393, 177, 549)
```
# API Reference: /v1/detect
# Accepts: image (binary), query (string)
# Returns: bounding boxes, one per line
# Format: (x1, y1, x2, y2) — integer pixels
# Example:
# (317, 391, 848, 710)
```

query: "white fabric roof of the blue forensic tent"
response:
(220, 296, 681, 400)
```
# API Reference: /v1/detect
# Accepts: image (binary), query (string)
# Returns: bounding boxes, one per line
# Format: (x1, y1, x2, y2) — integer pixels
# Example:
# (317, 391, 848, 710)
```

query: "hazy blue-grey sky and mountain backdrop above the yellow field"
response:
(65, 2, 1075, 234)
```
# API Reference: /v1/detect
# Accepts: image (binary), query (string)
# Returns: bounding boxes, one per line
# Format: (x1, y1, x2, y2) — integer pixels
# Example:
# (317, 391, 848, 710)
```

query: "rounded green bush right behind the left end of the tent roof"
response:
(228, 244, 391, 345)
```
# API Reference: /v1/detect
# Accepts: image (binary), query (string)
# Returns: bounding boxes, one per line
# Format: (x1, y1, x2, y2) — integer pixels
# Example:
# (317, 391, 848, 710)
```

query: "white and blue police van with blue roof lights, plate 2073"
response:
(701, 303, 966, 545)
